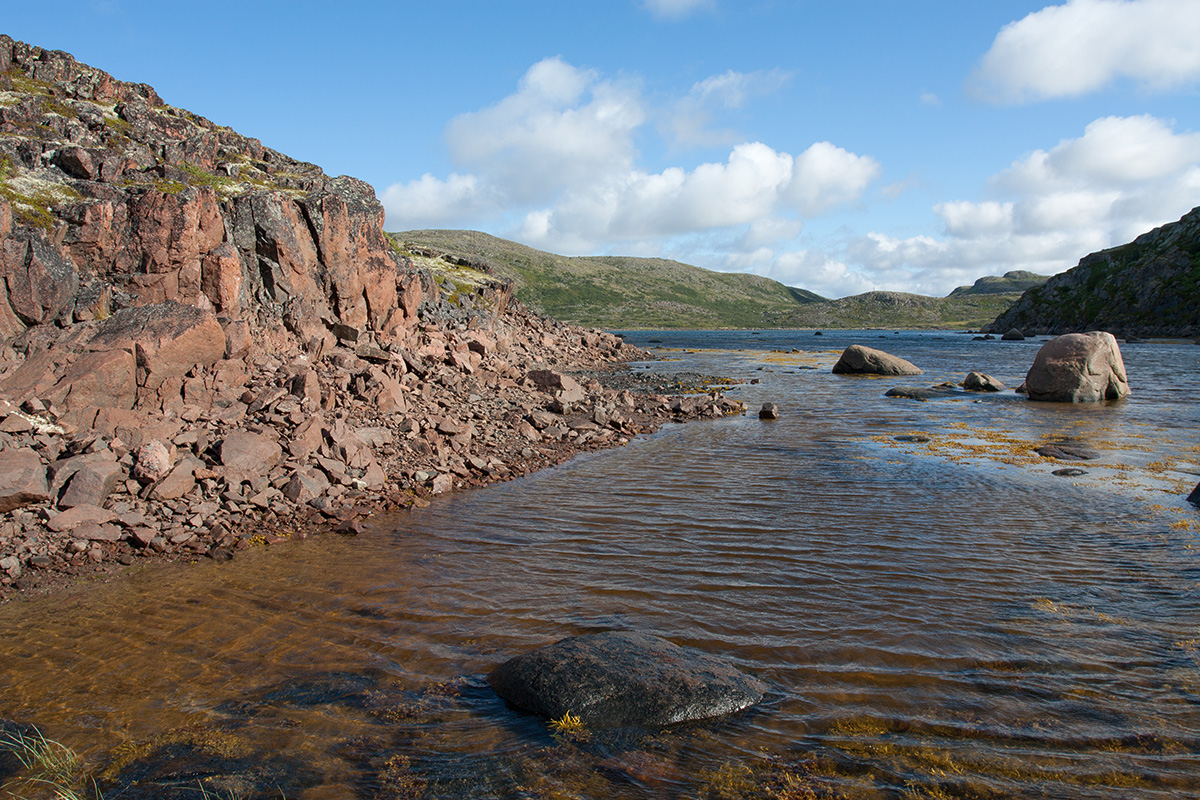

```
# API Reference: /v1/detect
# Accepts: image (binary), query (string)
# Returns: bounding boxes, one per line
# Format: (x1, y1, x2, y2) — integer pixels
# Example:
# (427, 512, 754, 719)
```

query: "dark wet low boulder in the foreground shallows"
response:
(487, 631, 766, 728)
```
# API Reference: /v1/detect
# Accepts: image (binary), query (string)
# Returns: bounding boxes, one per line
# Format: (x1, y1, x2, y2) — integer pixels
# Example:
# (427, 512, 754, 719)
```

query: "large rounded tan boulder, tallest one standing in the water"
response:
(1025, 331, 1129, 403)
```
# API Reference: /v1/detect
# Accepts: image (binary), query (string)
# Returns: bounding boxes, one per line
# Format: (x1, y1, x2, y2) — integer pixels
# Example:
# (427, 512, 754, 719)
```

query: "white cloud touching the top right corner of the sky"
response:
(970, 0, 1200, 103)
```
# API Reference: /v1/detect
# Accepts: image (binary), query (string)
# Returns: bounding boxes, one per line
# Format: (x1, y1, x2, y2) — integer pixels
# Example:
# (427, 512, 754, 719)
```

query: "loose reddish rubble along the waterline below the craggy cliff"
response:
(0, 335, 744, 602)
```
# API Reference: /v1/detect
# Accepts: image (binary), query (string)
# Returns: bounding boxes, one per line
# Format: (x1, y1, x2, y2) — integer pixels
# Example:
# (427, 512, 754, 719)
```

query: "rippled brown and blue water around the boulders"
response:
(0, 335, 1200, 799)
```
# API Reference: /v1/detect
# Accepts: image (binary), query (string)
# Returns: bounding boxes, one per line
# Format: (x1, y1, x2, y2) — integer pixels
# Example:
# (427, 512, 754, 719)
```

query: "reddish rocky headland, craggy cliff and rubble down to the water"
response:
(0, 36, 743, 599)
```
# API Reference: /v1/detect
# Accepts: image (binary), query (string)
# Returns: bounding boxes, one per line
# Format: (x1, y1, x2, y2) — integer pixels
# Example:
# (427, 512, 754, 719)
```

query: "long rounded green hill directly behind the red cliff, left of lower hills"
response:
(390, 230, 822, 330)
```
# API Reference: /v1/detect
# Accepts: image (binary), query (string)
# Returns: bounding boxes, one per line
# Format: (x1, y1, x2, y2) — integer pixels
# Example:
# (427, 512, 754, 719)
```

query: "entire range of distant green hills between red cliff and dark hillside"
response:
(390, 230, 1022, 330)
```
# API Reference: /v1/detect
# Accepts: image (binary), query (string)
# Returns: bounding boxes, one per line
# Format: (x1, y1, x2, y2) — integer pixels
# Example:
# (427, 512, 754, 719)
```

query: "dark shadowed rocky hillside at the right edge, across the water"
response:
(985, 207, 1200, 337)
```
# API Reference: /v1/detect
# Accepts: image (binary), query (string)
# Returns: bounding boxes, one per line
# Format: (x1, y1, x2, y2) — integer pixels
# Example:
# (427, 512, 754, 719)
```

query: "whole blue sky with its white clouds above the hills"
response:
(4, 0, 1200, 296)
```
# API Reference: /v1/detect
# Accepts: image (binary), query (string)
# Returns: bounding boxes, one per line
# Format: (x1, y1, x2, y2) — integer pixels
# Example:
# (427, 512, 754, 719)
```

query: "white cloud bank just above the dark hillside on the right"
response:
(820, 116, 1200, 295)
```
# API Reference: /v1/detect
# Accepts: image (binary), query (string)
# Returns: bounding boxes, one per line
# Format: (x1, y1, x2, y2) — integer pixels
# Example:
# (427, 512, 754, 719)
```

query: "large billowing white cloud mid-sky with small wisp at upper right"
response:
(382, 58, 881, 253)
